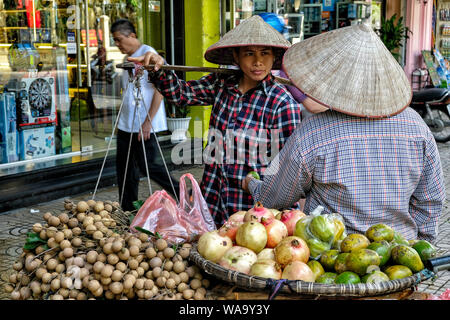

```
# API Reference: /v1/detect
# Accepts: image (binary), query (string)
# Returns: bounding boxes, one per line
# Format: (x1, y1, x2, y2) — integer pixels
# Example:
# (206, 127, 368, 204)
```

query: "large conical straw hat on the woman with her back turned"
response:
(283, 24, 412, 118)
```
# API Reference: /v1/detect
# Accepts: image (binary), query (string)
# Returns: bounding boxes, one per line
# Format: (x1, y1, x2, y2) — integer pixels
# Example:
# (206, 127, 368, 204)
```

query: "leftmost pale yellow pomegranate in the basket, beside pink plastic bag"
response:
(197, 230, 233, 263)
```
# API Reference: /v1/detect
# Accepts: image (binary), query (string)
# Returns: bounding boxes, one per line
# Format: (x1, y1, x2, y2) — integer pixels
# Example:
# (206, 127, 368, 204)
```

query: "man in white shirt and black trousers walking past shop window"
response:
(111, 19, 179, 211)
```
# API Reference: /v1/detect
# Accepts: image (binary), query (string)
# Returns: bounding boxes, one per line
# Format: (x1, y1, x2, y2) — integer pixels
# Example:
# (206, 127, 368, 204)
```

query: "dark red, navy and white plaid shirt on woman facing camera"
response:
(151, 70, 301, 225)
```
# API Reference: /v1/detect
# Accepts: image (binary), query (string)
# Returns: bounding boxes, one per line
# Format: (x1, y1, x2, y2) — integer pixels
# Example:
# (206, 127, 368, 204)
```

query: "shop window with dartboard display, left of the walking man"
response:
(0, 0, 148, 176)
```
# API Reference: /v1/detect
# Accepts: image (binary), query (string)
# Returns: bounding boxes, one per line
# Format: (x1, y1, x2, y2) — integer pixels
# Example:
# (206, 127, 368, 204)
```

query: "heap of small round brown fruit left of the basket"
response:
(5, 200, 210, 300)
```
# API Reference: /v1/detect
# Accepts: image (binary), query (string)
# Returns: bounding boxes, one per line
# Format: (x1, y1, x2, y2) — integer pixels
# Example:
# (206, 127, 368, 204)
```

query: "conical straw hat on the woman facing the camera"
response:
(205, 15, 291, 69)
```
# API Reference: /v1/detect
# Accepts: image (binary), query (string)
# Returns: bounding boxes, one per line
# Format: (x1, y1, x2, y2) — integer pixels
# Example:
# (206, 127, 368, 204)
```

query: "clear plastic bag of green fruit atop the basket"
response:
(296, 206, 347, 260)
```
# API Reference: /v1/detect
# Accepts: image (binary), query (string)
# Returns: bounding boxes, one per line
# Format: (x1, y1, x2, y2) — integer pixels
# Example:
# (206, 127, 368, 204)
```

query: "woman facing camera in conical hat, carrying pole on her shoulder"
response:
(128, 16, 301, 225)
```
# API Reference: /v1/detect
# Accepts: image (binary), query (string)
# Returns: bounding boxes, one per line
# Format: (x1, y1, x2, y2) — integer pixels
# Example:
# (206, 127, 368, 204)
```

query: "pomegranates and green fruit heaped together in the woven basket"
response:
(197, 204, 436, 284)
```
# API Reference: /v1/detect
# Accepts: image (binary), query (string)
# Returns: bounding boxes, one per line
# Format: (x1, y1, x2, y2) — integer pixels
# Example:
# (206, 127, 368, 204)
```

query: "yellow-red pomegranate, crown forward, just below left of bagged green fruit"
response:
(274, 236, 310, 268)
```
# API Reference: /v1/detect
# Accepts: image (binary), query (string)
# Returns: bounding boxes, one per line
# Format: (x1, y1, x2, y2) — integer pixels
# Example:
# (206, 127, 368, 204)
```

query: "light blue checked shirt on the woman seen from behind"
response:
(249, 108, 445, 241)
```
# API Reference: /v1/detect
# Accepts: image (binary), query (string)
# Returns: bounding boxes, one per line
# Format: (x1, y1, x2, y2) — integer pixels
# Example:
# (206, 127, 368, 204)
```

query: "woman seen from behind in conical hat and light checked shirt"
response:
(242, 24, 445, 241)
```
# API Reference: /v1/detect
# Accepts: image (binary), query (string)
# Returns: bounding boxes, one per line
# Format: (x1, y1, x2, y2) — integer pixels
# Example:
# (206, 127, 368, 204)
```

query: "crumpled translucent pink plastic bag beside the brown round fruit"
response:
(130, 173, 216, 244)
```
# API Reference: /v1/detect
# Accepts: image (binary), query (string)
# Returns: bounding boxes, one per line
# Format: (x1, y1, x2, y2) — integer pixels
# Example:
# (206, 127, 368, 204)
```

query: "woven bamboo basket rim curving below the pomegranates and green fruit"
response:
(189, 246, 433, 298)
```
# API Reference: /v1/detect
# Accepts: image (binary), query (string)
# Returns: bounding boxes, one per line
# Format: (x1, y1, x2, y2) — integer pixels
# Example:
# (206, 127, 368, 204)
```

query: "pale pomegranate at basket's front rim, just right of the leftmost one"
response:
(218, 246, 257, 274)
